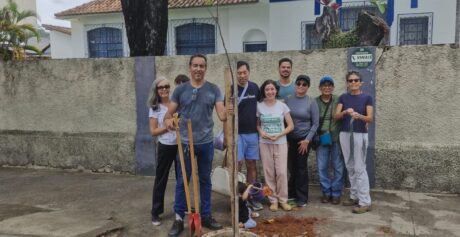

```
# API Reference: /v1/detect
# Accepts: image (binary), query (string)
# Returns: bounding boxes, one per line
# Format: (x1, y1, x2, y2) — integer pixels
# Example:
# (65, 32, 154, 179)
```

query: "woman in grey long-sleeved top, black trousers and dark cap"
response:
(286, 75, 319, 207)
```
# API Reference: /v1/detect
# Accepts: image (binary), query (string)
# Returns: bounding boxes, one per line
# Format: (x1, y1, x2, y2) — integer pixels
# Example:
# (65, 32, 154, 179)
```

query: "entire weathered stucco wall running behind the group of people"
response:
(0, 45, 460, 193)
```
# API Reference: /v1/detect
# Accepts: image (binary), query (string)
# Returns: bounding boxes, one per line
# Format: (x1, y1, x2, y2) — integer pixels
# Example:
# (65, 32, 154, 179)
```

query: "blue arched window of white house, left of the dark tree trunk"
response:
(88, 27, 123, 58)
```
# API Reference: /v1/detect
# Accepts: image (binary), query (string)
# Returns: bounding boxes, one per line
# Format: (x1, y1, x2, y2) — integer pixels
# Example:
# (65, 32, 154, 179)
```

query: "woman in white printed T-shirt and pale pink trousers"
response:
(257, 80, 294, 211)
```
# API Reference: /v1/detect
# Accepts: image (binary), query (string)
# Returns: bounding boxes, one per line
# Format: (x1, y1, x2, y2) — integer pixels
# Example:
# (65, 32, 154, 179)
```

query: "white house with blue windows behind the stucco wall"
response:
(45, 0, 457, 58)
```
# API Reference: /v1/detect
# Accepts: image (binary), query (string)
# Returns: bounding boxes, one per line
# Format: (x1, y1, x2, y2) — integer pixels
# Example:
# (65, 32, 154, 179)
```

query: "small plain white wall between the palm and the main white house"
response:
(50, 31, 73, 59)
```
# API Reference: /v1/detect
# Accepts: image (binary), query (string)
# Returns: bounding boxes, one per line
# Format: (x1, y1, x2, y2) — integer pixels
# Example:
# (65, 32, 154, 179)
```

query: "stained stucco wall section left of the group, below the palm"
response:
(0, 58, 136, 172)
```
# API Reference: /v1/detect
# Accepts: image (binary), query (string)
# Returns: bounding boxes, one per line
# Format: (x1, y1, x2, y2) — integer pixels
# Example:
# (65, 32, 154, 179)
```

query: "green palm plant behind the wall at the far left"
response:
(0, 0, 41, 61)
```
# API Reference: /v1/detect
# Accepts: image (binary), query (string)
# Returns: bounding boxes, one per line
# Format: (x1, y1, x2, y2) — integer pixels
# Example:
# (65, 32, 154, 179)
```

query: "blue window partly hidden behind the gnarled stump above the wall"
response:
(339, 2, 385, 31)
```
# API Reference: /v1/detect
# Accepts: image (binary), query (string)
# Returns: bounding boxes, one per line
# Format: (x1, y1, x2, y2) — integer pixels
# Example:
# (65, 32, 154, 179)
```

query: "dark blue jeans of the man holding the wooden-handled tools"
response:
(174, 142, 214, 218)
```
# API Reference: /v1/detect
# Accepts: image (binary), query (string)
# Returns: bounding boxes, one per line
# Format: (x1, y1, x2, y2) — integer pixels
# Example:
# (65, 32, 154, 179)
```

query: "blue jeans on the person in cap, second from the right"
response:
(316, 142, 344, 197)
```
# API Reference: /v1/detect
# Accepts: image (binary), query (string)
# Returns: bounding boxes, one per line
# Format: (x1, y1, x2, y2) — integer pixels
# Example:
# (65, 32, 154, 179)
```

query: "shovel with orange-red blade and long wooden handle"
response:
(187, 119, 201, 236)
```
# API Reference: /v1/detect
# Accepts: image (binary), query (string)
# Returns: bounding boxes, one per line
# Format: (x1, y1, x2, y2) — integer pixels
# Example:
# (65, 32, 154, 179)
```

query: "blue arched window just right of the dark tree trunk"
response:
(175, 22, 216, 55)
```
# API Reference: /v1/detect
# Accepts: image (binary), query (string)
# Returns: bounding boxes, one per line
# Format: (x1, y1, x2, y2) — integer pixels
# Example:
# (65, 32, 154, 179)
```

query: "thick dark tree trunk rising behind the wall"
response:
(121, 0, 168, 56)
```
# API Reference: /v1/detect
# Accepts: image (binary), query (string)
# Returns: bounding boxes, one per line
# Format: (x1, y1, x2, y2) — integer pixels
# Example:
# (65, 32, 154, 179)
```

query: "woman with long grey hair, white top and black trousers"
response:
(148, 77, 177, 225)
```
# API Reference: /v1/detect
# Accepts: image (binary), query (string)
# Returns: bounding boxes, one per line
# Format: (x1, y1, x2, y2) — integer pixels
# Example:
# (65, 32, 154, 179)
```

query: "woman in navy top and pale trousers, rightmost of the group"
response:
(334, 71, 374, 214)
